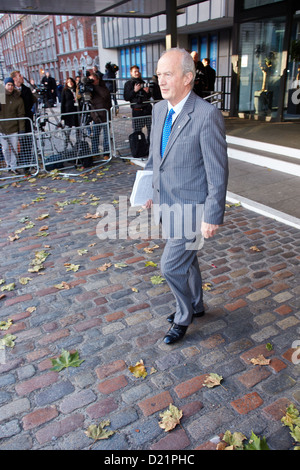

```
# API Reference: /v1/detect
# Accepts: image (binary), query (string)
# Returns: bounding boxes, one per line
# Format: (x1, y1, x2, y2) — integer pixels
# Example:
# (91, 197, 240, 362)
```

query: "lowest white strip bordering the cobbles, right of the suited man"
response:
(226, 191, 300, 230)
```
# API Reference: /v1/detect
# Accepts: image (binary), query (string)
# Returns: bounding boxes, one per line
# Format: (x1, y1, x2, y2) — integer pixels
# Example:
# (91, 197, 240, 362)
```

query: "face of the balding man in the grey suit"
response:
(157, 51, 193, 106)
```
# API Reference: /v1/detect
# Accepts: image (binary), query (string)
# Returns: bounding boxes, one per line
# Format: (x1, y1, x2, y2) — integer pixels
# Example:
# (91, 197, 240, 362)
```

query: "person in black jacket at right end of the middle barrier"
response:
(89, 73, 111, 155)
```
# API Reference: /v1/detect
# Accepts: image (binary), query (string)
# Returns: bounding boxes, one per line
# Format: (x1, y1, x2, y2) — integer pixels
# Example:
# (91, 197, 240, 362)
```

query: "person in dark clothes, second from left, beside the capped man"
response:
(10, 70, 37, 174)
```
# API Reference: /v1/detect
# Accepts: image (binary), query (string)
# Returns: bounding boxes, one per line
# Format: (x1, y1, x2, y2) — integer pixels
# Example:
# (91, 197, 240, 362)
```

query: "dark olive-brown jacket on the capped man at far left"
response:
(0, 89, 25, 134)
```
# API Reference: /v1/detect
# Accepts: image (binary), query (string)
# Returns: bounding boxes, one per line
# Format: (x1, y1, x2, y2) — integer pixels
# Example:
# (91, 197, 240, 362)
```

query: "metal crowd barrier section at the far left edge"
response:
(0, 118, 39, 181)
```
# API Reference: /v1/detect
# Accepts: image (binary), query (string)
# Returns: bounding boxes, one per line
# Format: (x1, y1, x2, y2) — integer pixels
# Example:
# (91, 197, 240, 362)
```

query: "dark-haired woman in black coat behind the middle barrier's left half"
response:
(60, 77, 79, 150)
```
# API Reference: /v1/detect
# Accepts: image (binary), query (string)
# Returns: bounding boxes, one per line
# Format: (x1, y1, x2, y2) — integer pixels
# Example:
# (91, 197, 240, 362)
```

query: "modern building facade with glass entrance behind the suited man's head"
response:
(100, 0, 300, 121)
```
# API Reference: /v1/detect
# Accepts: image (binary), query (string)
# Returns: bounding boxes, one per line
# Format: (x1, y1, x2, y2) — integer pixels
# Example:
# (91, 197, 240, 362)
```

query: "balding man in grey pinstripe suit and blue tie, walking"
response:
(145, 48, 228, 344)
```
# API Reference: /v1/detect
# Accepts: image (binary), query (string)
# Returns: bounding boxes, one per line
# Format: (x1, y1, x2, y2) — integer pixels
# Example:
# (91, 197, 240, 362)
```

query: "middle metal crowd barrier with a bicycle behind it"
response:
(36, 109, 112, 176)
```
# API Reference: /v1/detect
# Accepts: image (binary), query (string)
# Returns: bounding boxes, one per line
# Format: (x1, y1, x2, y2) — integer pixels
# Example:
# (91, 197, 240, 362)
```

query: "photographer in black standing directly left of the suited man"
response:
(124, 65, 152, 142)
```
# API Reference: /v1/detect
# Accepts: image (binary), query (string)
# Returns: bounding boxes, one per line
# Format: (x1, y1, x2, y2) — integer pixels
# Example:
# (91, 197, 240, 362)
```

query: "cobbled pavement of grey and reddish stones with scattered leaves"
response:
(0, 159, 300, 451)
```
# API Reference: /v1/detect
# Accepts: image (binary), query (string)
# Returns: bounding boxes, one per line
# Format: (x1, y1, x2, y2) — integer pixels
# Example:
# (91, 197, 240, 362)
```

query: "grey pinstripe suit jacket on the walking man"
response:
(145, 91, 228, 239)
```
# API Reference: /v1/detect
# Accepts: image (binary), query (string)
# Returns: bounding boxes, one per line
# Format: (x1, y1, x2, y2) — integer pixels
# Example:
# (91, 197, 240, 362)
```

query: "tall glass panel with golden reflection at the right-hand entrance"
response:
(239, 18, 285, 116)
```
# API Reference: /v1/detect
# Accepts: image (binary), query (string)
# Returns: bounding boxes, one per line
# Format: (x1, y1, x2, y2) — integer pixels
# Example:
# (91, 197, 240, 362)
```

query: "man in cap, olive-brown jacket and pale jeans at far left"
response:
(0, 77, 25, 174)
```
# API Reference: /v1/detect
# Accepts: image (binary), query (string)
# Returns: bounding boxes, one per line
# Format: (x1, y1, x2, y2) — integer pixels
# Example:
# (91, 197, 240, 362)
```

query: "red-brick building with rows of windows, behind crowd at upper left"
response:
(0, 14, 99, 83)
